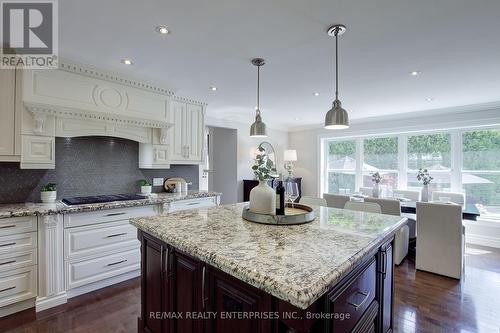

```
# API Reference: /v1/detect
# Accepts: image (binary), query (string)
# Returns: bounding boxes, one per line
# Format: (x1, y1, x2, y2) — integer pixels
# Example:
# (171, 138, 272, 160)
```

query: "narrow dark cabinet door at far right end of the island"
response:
(378, 243, 394, 333)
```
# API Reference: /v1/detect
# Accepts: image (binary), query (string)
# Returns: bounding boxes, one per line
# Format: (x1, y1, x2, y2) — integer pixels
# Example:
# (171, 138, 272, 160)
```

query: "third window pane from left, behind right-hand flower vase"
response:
(407, 133, 451, 191)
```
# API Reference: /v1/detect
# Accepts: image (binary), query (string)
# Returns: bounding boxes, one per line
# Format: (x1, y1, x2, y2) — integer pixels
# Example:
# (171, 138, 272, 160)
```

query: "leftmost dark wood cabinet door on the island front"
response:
(139, 234, 170, 333)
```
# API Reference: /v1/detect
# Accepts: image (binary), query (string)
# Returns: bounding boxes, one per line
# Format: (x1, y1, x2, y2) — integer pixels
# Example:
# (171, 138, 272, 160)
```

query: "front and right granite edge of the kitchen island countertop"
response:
(130, 213, 407, 310)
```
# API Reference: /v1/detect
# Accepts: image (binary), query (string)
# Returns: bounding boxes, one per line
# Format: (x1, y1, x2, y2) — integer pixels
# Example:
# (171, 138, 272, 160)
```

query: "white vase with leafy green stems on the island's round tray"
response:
(250, 146, 276, 215)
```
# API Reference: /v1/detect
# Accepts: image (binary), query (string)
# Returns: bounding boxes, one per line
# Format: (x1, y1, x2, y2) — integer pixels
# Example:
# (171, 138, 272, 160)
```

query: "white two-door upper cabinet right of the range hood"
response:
(169, 100, 205, 164)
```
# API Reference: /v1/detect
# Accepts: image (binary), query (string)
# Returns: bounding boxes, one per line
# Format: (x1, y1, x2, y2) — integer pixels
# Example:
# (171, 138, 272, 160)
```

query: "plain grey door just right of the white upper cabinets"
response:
(208, 127, 238, 204)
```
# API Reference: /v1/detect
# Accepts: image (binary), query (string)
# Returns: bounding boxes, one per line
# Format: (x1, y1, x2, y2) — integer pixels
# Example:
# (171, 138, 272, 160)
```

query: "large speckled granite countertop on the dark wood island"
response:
(131, 203, 406, 309)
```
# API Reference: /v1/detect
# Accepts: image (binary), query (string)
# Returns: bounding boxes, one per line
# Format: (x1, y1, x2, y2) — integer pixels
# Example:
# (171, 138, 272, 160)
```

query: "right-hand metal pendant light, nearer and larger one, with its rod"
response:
(325, 24, 349, 129)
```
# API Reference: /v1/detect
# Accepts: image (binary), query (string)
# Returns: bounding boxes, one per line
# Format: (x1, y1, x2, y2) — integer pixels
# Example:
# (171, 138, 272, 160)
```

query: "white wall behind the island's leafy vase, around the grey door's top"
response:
(205, 117, 288, 201)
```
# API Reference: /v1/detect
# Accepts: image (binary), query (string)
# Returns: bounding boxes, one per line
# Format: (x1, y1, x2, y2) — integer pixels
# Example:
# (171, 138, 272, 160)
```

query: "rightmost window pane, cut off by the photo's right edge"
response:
(461, 129, 500, 220)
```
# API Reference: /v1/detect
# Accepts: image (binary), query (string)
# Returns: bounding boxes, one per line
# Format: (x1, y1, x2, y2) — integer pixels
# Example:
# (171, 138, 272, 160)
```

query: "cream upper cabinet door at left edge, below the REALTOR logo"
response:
(0, 69, 16, 155)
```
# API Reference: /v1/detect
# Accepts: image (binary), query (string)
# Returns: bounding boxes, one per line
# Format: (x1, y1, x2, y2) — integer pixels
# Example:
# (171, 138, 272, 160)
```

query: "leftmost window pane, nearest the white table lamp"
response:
(325, 140, 356, 193)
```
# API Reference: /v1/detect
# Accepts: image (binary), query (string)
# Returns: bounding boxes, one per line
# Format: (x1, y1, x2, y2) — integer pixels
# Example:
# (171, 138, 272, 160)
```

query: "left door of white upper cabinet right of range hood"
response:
(168, 101, 186, 161)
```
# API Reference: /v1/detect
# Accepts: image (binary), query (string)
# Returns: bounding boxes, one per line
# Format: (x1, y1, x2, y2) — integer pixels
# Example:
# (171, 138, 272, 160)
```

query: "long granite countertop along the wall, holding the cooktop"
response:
(0, 191, 221, 218)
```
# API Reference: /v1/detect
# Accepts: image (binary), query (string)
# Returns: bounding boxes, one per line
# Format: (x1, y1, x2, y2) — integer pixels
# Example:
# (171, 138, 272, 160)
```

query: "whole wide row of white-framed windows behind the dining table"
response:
(321, 128, 500, 221)
